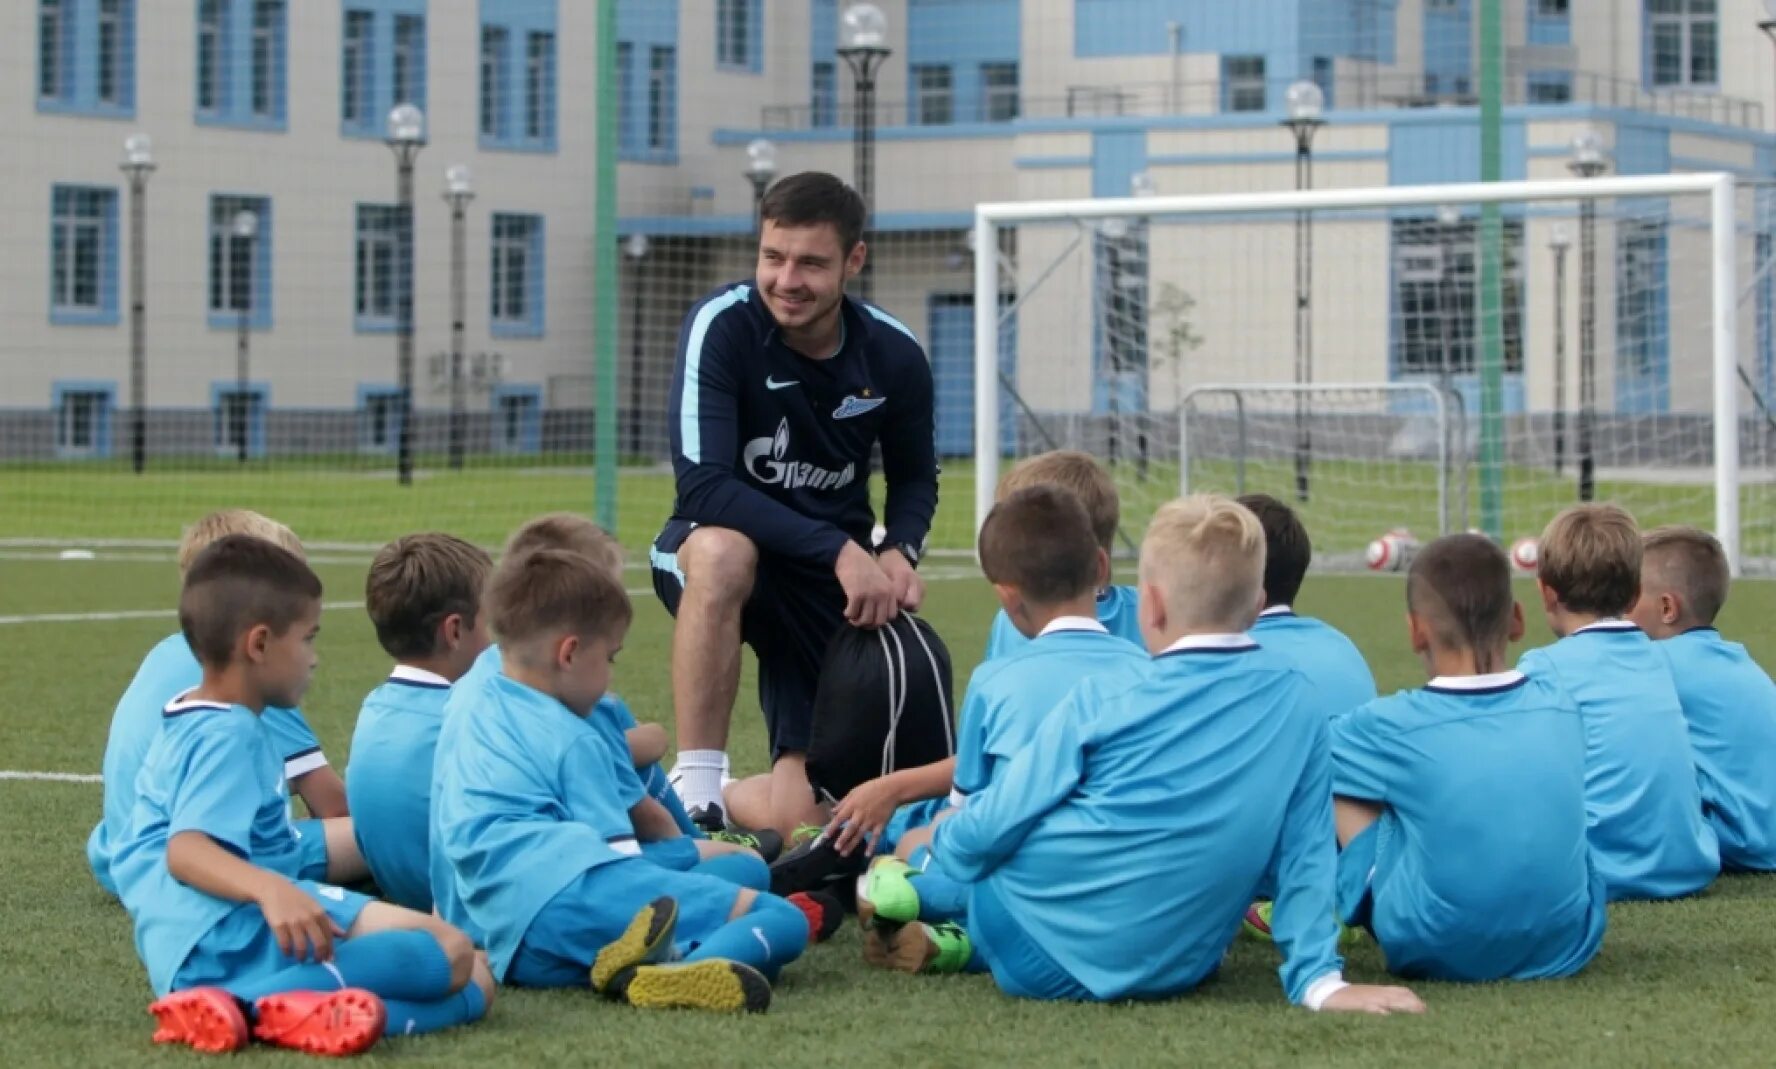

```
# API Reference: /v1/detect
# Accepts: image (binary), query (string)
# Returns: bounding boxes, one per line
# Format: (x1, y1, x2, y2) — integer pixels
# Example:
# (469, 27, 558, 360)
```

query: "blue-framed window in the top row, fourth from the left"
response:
(476, 0, 558, 153)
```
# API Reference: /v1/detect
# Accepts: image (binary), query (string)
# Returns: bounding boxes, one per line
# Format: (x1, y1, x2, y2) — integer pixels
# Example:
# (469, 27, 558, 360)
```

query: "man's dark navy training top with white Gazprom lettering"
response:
(670, 282, 938, 566)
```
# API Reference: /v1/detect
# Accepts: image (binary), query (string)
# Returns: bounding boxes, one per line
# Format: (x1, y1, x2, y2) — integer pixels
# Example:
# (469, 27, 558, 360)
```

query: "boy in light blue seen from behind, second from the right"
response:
(1517, 504, 1721, 902)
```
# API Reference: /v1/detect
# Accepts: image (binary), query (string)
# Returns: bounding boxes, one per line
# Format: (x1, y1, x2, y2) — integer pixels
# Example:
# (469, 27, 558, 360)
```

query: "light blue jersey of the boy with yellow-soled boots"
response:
(432, 673, 641, 980)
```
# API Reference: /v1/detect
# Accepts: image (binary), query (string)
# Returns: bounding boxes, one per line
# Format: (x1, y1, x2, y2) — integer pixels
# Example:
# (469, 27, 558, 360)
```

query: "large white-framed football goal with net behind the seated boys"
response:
(971, 174, 1776, 570)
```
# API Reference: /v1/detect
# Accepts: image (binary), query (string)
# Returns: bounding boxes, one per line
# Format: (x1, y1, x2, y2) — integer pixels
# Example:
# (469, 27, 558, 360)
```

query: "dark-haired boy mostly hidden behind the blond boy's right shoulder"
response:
(1240, 494, 1375, 716)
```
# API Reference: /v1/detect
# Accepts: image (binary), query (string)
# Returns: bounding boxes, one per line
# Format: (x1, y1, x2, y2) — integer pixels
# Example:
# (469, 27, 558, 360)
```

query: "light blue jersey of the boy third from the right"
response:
(1332, 671, 1606, 980)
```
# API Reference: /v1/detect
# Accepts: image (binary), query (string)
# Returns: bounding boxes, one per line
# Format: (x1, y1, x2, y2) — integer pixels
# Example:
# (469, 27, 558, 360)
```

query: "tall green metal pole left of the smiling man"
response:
(591, 0, 618, 533)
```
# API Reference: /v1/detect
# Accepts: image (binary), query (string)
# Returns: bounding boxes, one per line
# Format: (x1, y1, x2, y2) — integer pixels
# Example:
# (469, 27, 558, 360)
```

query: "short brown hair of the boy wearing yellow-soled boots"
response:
(487, 549, 634, 645)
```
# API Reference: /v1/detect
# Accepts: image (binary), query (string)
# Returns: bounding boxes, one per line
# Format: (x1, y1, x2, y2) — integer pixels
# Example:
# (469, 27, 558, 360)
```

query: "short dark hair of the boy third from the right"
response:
(1407, 535, 1515, 653)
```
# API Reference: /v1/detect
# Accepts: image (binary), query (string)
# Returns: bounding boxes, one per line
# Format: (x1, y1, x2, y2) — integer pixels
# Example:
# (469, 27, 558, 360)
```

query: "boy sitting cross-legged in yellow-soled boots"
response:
(433, 549, 808, 1010)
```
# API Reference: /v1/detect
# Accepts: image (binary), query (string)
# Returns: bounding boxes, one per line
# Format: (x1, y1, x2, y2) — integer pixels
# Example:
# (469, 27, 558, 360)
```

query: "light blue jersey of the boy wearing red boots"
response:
(110, 696, 312, 994)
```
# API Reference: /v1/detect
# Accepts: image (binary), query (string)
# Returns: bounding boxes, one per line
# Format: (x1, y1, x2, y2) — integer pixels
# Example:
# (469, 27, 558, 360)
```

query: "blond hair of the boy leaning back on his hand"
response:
(1140, 494, 1265, 630)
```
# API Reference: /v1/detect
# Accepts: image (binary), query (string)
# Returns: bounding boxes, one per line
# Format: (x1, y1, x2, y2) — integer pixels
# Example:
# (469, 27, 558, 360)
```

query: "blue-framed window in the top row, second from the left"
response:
(194, 0, 289, 130)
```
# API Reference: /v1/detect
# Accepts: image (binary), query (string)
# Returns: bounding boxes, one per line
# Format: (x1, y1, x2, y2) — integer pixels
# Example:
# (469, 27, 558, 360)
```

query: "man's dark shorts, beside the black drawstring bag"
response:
(648, 519, 847, 762)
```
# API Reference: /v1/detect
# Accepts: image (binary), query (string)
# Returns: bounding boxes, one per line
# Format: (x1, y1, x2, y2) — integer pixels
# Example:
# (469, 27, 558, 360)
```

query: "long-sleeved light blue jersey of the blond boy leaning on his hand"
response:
(934, 634, 1343, 1007)
